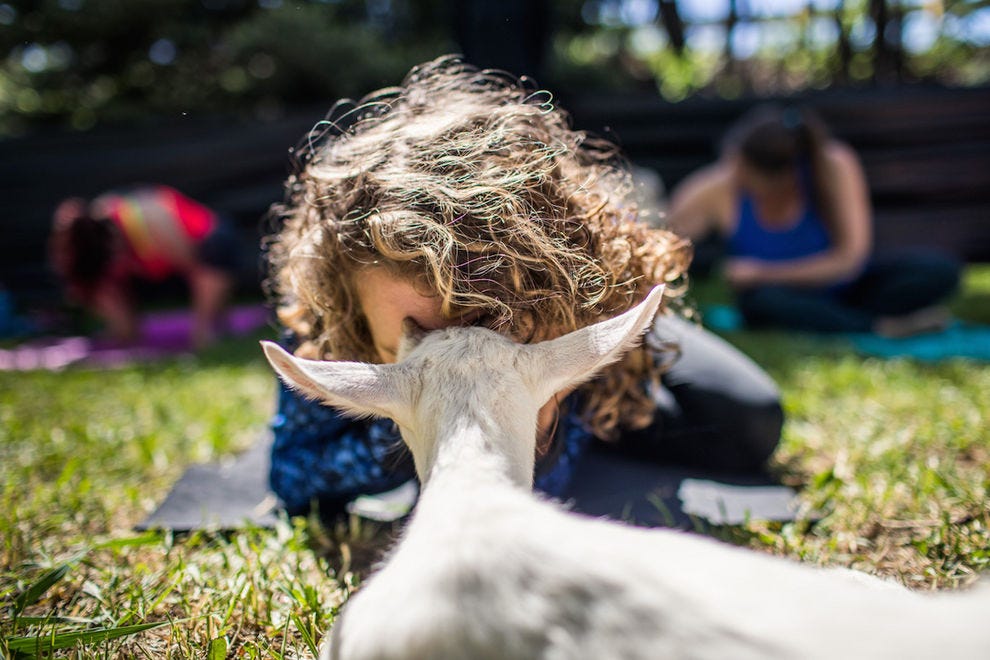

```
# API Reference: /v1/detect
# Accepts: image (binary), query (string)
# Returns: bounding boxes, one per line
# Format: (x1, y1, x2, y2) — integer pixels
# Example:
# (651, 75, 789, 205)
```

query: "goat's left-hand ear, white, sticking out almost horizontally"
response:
(261, 341, 401, 418)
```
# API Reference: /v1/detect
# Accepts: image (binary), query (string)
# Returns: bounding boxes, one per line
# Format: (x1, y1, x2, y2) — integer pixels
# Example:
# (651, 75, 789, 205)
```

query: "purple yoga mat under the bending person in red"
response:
(0, 305, 268, 371)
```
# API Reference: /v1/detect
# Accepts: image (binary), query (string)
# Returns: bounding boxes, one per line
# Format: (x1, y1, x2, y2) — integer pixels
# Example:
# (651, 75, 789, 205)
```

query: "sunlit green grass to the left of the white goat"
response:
(0, 338, 342, 658)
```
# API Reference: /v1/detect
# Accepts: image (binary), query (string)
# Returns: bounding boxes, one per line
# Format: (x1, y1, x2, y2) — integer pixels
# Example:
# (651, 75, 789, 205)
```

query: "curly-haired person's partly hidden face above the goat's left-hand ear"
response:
(354, 268, 477, 363)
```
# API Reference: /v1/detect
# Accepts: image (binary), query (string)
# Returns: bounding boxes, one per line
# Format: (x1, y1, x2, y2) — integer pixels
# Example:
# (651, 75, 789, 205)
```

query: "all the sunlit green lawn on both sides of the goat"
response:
(0, 267, 990, 659)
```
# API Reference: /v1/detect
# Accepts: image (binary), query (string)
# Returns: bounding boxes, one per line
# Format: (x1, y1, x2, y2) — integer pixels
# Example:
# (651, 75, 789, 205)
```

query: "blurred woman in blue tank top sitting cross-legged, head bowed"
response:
(669, 105, 960, 336)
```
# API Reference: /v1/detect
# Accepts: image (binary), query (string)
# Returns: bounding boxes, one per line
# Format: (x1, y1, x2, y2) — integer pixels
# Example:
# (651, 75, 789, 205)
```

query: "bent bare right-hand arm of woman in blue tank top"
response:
(726, 143, 873, 288)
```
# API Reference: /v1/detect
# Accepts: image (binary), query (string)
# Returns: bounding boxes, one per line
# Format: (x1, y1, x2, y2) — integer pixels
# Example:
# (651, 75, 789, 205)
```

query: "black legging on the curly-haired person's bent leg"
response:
(608, 317, 784, 472)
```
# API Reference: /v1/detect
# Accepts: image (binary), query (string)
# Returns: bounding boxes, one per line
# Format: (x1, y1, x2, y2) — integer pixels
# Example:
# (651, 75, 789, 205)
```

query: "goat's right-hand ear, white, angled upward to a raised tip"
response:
(520, 286, 663, 399)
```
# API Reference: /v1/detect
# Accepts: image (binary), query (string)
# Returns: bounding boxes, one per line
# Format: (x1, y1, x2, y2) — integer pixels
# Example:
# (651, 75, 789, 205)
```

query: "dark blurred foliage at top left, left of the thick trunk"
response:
(0, 0, 456, 132)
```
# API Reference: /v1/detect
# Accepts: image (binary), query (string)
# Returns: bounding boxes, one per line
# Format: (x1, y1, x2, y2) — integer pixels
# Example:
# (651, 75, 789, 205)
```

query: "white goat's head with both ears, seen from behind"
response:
(262, 286, 663, 483)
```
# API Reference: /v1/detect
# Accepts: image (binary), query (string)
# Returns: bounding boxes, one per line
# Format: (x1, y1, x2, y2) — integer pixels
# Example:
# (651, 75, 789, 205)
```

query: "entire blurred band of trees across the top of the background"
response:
(0, 0, 990, 134)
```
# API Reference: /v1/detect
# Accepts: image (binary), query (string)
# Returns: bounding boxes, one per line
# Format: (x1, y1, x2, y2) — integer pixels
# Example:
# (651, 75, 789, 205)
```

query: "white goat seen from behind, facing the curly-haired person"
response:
(264, 288, 990, 660)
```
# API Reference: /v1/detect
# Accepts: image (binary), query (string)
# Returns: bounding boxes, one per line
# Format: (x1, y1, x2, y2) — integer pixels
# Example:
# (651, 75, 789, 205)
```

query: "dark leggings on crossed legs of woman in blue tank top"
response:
(738, 252, 960, 332)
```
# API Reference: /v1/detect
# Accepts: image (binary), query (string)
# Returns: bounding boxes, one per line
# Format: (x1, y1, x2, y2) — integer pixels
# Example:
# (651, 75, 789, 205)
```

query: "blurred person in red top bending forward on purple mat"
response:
(49, 185, 243, 348)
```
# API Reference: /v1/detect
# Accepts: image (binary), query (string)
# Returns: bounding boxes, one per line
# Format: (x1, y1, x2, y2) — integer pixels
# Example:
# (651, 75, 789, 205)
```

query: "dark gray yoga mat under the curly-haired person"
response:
(138, 436, 795, 532)
